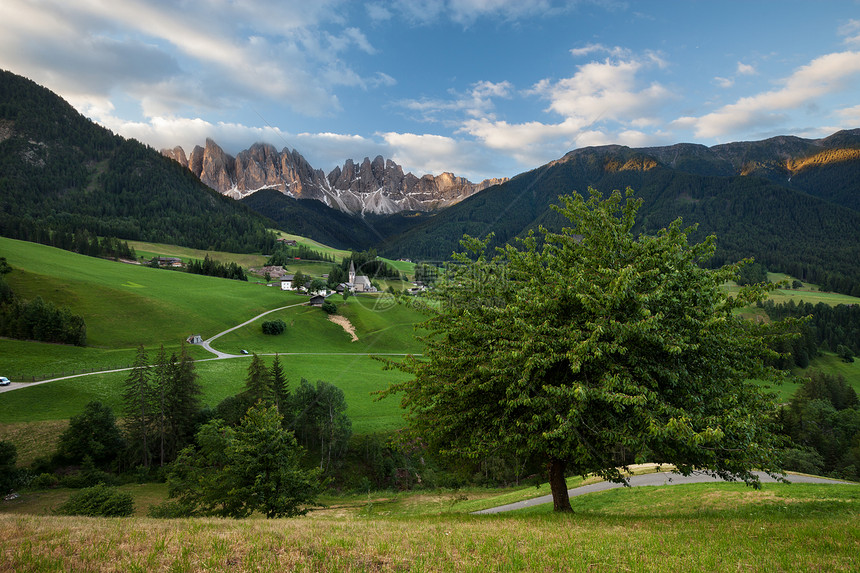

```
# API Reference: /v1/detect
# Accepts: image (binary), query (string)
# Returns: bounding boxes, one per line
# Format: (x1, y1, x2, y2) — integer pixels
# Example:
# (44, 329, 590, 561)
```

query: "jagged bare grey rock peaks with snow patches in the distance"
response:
(162, 139, 505, 215)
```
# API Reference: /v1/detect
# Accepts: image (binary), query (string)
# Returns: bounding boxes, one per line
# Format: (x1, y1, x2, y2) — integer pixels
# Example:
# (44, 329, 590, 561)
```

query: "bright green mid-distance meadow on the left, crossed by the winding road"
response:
(0, 233, 424, 460)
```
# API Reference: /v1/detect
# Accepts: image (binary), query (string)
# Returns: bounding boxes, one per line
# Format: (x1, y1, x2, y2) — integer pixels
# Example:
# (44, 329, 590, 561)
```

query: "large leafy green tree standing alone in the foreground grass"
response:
(388, 189, 792, 511)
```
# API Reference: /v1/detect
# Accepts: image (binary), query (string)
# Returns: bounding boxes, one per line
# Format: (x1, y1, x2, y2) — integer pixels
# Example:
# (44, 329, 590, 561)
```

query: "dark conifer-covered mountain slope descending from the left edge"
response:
(0, 71, 274, 252)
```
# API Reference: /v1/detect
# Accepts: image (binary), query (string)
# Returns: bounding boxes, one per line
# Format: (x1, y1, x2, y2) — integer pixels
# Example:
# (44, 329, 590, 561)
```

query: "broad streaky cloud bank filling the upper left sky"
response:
(0, 0, 380, 122)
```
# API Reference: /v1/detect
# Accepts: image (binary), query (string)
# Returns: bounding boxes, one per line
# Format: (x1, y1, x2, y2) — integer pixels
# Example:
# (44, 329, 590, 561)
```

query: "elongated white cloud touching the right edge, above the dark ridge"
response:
(675, 52, 860, 138)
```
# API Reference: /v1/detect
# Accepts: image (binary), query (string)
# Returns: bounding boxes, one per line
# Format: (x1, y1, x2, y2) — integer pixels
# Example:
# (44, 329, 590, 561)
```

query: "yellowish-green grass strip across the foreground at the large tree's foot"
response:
(0, 484, 860, 572)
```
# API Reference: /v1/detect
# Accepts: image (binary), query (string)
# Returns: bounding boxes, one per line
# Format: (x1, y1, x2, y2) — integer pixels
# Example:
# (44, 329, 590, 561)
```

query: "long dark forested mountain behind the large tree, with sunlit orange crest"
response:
(380, 130, 860, 294)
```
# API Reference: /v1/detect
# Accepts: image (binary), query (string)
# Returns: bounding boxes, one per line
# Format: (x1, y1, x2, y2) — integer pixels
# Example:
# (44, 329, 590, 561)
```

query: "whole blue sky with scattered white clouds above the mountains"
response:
(0, 0, 860, 181)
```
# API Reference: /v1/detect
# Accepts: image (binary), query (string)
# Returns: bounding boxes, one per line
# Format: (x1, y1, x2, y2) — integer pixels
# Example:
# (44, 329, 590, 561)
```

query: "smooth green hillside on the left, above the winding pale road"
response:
(0, 238, 300, 348)
